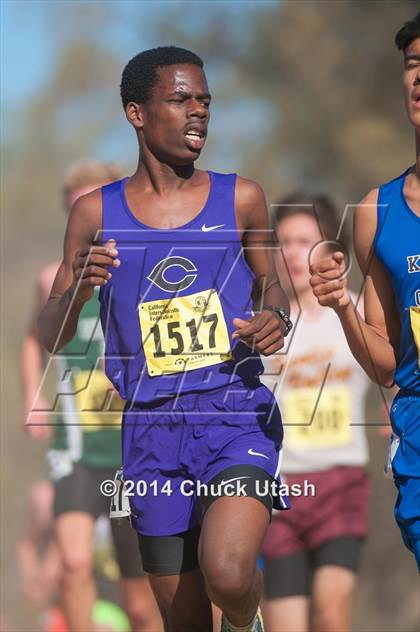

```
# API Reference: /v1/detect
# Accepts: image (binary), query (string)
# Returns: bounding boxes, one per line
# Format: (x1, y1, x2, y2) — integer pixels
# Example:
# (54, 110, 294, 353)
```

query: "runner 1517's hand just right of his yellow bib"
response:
(232, 309, 286, 356)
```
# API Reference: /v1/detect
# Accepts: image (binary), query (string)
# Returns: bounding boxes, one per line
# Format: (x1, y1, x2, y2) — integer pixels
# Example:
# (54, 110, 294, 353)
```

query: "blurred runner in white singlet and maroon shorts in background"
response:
(262, 193, 369, 632)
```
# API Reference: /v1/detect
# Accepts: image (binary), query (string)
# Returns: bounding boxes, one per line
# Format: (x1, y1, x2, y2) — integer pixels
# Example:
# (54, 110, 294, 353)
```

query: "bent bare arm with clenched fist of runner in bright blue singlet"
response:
(311, 189, 399, 387)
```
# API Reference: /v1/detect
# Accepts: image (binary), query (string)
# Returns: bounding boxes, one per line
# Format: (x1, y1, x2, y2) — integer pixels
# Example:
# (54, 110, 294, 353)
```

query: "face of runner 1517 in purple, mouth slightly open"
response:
(141, 64, 210, 166)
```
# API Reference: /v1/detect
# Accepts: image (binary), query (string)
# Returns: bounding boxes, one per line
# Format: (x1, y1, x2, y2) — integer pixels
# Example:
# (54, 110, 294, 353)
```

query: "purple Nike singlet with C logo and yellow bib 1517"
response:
(100, 172, 263, 403)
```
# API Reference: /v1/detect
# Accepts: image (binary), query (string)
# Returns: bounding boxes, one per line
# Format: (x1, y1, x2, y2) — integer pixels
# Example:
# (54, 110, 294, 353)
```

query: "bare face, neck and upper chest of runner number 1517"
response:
(121, 64, 211, 228)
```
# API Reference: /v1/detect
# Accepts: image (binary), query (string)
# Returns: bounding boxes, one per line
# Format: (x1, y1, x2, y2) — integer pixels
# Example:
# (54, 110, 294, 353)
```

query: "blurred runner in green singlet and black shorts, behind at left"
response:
(21, 161, 160, 632)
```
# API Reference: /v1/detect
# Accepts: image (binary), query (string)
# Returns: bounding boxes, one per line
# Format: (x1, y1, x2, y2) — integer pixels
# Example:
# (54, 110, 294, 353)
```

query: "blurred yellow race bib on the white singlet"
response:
(283, 388, 353, 448)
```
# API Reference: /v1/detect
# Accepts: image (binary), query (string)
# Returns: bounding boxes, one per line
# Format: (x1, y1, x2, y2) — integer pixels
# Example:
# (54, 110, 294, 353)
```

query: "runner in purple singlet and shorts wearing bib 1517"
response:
(40, 47, 291, 632)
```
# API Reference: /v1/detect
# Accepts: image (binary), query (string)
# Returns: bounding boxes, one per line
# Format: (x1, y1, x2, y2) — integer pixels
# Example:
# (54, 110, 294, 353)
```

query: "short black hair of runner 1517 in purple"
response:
(120, 46, 204, 109)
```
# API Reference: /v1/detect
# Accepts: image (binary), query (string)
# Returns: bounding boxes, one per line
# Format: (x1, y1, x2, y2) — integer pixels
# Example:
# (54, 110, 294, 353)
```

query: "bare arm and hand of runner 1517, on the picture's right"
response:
(234, 178, 290, 355)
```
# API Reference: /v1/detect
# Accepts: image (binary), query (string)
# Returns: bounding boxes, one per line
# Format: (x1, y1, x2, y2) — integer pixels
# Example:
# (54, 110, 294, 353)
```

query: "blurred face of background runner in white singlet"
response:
(276, 213, 322, 296)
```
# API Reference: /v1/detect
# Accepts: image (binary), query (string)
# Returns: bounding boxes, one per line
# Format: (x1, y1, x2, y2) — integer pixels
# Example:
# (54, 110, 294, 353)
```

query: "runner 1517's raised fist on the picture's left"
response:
(72, 239, 121, 303)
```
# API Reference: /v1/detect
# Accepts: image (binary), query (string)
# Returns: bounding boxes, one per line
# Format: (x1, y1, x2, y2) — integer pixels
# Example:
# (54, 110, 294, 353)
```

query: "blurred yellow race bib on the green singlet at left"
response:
(73, 370, 124, 432)
